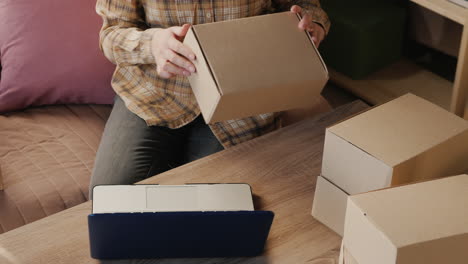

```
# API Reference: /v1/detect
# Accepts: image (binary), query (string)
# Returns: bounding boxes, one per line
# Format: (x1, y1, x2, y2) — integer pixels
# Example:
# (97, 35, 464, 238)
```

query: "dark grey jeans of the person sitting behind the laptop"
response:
(89, 96, 223, 198)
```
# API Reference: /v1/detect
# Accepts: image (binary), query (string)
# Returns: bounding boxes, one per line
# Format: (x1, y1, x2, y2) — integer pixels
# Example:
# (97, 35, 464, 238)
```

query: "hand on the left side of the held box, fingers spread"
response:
(151, 24, 196, 78)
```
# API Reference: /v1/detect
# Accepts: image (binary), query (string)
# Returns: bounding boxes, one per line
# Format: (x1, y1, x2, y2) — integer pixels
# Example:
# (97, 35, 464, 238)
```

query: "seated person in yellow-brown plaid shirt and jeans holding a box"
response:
(90, 0, 330, 197)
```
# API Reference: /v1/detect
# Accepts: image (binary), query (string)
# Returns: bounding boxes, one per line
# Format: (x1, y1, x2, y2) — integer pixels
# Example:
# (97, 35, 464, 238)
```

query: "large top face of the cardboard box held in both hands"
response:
(193, 12, 328, 95)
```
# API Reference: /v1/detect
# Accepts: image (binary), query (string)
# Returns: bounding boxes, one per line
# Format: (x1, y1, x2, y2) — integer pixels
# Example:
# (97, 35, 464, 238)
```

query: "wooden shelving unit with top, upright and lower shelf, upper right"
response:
(330, 0, 468, 119)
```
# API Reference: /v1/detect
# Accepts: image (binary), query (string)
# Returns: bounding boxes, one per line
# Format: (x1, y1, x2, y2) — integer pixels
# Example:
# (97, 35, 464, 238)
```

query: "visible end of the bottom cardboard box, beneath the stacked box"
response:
(312, 176, 348, 236)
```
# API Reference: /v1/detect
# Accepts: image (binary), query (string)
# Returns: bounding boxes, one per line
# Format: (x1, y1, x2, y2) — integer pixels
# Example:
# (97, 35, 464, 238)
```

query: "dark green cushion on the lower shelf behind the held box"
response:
(320, 0, 406, 79)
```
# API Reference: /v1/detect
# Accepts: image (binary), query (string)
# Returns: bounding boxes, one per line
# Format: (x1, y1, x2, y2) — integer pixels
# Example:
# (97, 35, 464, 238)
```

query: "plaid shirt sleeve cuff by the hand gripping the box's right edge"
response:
(272, 0, 330, 34)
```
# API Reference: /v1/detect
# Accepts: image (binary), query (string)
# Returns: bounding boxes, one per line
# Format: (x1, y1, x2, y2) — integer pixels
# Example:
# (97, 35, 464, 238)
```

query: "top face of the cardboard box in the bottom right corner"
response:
(345, 175, 468, 248)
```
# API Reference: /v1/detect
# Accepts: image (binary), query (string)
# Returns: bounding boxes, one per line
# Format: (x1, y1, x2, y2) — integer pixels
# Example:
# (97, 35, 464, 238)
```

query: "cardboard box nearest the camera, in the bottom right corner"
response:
(343, 175, 468, 264)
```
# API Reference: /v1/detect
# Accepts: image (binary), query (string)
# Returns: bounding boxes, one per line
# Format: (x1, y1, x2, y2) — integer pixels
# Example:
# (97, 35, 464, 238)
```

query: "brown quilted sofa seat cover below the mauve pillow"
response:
(0, 105, 111, 233)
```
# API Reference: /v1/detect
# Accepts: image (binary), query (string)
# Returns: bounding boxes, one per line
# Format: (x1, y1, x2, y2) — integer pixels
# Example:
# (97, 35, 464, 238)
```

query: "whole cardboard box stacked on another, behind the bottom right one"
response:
(322, 94, 468, 195)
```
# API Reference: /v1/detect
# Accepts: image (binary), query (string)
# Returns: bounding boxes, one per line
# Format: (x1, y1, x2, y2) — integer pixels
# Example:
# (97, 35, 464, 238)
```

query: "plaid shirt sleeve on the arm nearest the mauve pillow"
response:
(96, 0, 160, 66)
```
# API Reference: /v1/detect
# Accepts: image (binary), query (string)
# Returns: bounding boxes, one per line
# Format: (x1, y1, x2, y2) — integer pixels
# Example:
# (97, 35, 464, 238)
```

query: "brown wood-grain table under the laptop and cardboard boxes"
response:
(0, 101, 368, 264)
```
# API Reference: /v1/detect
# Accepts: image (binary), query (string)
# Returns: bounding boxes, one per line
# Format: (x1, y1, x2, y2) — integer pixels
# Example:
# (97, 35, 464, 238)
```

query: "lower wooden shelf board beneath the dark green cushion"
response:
(329, 59, 468, 118)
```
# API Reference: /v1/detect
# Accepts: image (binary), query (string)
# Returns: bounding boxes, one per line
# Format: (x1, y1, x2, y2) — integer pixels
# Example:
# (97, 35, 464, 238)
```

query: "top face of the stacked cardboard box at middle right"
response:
(328, 94, 468, 166)
